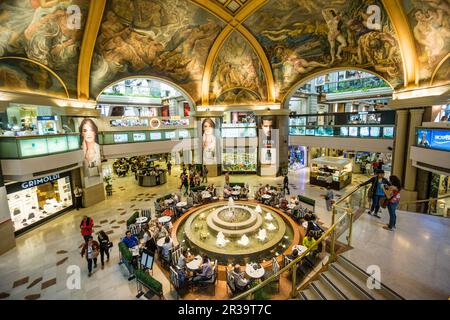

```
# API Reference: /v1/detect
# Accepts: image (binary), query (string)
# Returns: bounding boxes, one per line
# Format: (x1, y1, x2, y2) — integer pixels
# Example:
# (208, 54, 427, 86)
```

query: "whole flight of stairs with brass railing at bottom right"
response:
(298, 256, 404, 300)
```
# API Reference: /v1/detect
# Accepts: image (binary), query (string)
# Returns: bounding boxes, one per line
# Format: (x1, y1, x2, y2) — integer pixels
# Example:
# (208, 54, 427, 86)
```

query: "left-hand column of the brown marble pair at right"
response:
(392, 110, 409, 183)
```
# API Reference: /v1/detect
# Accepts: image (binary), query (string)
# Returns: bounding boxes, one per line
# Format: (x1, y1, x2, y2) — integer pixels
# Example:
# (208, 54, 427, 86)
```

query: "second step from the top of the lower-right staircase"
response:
(326, 264, 375, 300)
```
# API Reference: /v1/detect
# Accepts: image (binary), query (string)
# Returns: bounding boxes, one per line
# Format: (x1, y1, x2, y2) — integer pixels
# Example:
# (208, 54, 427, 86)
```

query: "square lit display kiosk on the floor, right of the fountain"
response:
(309, 157, 352, 190)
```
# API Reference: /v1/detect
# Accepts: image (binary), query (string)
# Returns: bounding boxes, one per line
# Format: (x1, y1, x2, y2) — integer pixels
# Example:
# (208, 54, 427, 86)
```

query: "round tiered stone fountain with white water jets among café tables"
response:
(174, 198, 294, 264)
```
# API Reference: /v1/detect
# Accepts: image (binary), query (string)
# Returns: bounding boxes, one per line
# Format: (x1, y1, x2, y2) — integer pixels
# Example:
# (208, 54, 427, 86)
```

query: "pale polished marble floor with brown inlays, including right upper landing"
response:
(0, 168, 450, 299)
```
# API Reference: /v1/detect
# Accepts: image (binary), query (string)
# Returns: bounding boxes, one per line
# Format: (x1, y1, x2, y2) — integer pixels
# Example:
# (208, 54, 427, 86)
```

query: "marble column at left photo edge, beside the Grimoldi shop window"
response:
(0, 164, 16, 255)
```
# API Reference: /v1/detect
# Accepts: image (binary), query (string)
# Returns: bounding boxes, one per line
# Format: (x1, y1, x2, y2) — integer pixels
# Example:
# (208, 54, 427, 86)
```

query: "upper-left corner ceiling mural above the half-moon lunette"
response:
(0, 0, 89, 96)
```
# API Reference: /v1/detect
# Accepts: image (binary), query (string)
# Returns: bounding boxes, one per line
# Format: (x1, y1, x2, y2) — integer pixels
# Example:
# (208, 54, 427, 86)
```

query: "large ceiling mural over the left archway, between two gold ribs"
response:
(91, 0, 223, 101)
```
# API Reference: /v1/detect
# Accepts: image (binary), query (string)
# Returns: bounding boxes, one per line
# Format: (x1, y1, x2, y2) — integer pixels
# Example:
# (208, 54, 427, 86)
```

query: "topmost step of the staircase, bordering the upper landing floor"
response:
(333, 256, 404, 300)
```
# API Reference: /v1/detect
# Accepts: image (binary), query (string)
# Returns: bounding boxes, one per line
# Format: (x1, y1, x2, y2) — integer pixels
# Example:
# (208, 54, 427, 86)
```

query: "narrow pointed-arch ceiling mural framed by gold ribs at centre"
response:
(209, 32, 267, 103)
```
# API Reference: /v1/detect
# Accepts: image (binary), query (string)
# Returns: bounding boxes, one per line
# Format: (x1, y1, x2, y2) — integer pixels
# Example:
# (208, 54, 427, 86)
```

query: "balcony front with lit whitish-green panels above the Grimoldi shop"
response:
(0, 133, 80, 159)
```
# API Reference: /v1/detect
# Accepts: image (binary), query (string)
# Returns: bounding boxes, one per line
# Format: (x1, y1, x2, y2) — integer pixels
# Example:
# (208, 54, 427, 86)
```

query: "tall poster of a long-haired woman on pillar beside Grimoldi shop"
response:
(79, 118, 102, 188)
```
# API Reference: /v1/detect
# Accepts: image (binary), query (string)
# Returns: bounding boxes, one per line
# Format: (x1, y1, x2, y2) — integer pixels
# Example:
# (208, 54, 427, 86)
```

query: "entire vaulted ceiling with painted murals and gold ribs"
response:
(0, 0, 450, 105)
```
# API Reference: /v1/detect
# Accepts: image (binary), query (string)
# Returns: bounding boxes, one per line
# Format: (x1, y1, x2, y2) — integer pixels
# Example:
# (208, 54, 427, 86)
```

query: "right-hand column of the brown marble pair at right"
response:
(405, 109, 424, 191)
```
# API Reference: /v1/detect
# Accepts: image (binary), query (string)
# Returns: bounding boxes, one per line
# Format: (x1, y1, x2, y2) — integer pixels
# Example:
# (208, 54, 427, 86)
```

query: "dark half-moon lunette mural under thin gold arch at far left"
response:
(0, 58, 67, 98)
